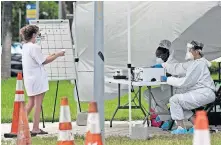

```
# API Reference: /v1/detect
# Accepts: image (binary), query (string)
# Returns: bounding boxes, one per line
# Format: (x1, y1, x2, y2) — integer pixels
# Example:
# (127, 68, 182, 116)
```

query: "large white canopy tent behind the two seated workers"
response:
(72, 1, 221, 101)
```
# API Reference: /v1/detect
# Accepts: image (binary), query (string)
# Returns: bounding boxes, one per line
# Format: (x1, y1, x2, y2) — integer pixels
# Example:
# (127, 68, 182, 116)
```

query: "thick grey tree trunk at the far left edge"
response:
(1, 1, 12, 79)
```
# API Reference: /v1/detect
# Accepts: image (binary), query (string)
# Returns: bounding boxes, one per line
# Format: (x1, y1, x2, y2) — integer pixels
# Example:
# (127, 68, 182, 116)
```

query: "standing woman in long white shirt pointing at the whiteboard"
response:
(20, 25, 65, 134)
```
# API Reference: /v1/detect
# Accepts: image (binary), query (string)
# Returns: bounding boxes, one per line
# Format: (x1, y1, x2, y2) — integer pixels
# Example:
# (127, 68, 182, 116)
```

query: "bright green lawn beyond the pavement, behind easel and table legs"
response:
(1, 78, 147, 123)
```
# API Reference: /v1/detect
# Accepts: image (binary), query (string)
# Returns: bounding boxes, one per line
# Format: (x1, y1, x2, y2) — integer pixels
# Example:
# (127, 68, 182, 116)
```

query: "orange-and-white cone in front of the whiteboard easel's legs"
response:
(57, 97, 75, 145)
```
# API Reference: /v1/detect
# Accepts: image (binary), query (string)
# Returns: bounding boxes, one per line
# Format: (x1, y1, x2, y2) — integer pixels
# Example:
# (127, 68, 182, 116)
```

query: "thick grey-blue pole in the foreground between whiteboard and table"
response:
(93, 1, 104, 144)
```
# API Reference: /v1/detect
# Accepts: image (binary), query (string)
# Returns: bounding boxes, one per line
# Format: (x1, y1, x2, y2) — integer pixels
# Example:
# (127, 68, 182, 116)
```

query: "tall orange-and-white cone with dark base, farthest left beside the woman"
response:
(4, 72, 25, 138)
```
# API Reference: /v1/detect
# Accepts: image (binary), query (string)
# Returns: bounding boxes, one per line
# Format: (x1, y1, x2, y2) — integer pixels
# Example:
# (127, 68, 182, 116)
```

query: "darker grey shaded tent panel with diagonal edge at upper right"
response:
(172, 6, 221, 61)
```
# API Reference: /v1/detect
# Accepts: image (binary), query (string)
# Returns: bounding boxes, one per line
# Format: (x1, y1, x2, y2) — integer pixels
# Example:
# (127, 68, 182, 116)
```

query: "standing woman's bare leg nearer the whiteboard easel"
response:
(32, 93, 45, 133)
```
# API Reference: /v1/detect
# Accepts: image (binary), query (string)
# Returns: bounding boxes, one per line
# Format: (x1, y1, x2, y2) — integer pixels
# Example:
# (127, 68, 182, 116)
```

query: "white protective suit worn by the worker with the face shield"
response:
(162, 58, 215, 120)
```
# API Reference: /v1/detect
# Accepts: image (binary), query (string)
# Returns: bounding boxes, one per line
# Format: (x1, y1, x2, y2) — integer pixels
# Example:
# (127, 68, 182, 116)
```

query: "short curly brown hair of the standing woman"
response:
(20, 25, 39, 41)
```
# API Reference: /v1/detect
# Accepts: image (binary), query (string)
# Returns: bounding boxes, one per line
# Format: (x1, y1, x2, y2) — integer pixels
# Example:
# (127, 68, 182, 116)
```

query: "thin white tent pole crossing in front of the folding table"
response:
(127, 2, 132, 136)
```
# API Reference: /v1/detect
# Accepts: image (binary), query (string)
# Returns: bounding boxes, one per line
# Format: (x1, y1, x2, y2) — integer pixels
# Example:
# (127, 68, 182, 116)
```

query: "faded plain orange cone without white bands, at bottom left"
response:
(17, 103, 31, 145)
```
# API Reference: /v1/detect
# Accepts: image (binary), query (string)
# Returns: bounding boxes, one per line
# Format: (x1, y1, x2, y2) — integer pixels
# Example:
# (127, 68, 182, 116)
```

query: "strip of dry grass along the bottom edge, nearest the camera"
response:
(2, 134, 221, 145)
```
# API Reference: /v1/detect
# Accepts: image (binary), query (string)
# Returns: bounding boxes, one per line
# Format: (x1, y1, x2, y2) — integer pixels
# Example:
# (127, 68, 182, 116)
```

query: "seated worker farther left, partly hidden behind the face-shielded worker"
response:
(144, 40, 178, 129)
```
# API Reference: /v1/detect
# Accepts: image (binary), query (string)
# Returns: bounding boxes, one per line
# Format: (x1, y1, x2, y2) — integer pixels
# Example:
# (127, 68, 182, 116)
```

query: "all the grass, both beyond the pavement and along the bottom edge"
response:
(1, 75, 221, 145)
